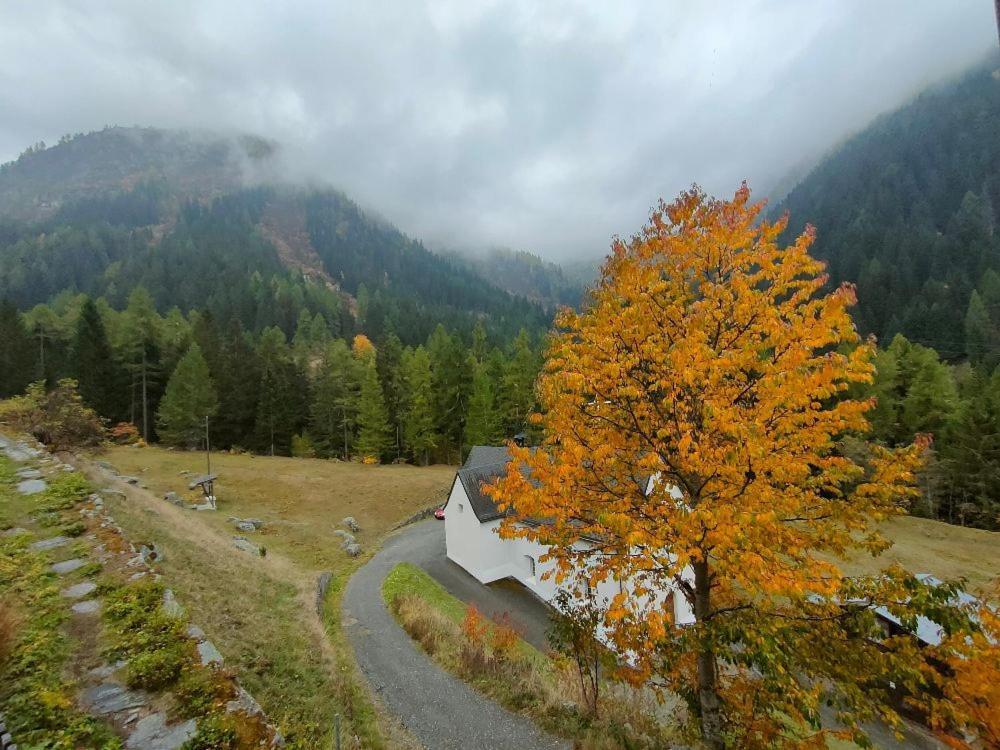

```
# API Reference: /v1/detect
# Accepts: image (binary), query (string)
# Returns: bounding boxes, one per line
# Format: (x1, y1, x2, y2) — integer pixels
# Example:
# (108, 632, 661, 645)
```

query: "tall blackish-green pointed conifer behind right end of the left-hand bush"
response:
(70, 297, 124, 420)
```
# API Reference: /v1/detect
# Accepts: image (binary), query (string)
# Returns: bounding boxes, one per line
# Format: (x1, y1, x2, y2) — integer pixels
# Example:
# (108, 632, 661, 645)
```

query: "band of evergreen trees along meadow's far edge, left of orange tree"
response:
(0, 287, 541, 463)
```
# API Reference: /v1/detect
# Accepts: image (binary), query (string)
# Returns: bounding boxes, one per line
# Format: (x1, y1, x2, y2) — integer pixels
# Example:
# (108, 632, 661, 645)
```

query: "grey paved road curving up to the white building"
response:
(343, 521, 570, 750)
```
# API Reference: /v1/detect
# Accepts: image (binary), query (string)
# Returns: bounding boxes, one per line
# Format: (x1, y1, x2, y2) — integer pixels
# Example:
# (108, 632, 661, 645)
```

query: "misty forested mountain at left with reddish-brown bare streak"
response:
(0, 128, 548, 343)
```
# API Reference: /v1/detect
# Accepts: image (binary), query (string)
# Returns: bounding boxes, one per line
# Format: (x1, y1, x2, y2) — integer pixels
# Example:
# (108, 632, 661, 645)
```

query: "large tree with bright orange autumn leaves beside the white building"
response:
(488, 185, 954, 748)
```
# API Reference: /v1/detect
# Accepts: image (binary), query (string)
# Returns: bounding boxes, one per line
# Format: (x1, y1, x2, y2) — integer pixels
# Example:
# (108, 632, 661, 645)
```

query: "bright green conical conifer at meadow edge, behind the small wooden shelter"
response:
(157, 344, 219, 448)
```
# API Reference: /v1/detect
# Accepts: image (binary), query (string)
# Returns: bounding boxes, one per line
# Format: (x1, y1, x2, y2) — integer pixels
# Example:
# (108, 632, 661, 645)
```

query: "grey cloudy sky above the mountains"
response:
(0, 0, 997, 259)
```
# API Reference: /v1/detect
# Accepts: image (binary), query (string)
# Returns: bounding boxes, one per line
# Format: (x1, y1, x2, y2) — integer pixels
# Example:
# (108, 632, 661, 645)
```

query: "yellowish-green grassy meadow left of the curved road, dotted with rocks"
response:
(86, 448, 454, 748)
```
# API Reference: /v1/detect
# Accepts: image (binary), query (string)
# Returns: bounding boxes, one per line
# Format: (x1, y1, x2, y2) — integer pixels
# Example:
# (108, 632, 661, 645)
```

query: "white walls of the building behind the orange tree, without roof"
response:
(444, 477, 694, 625)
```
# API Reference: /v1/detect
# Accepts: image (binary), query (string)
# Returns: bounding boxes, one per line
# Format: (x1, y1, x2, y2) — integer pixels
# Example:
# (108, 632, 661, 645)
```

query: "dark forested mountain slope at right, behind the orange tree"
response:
(775, 57, 1000, 360)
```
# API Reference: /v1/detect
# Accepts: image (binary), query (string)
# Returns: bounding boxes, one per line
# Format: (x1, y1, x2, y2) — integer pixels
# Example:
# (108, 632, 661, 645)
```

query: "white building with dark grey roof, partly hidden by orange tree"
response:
(444, 445, 694, 625)
